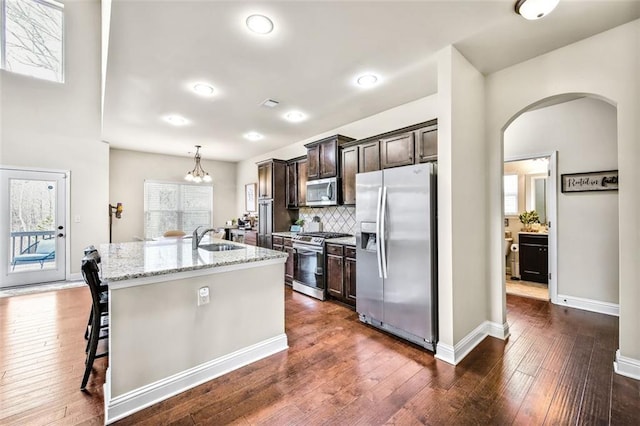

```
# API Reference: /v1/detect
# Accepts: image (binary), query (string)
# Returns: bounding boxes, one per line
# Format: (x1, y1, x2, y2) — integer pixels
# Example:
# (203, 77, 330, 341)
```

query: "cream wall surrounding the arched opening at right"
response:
(486, 20, 640, 360)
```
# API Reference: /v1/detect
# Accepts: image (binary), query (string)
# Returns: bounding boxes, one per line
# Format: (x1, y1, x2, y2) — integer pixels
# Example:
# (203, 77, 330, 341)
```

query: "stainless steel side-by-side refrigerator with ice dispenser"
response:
(356, 163, 438, 352)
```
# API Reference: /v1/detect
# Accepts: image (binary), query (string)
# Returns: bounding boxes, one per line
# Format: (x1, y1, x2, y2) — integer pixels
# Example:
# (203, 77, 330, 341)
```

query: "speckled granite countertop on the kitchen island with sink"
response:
(100, 237, 287, 281)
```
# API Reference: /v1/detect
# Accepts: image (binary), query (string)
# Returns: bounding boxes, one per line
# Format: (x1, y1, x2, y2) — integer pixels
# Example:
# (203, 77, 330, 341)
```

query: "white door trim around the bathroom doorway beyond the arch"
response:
(502, 148, 558, 305)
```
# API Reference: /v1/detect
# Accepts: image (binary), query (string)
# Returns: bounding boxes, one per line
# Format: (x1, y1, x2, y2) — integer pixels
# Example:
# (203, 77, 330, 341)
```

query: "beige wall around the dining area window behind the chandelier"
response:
(109, 149, 236, 243)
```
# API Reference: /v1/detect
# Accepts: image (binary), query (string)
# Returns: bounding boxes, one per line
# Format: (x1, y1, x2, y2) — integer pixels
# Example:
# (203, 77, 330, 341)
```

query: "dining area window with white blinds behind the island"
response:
(144, 181, 213, 239)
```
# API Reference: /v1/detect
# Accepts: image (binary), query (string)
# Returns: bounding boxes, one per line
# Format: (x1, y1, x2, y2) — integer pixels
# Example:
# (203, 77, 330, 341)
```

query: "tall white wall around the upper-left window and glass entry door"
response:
(0, 0, 109, 273)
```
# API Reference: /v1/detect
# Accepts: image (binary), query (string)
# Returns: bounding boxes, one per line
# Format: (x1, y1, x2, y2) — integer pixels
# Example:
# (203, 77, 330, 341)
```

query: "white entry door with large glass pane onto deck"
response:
(0, 168, 67, 288)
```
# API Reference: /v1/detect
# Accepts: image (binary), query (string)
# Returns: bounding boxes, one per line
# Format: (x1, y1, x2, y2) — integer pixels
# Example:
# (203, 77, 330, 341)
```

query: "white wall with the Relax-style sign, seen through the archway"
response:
(504, 98, 618, 304)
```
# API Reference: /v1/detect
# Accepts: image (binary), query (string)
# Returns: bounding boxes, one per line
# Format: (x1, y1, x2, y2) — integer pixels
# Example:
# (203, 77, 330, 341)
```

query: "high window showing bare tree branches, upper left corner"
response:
(0, 0, 64, 83)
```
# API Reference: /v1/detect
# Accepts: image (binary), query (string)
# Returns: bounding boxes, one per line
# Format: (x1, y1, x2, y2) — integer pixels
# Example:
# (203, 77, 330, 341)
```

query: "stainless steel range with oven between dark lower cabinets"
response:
(292, 232, 350, 300)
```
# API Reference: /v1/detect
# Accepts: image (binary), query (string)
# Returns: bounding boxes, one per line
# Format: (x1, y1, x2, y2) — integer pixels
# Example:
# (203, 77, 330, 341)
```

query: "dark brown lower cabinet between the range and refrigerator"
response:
(326, 244, 356, 306)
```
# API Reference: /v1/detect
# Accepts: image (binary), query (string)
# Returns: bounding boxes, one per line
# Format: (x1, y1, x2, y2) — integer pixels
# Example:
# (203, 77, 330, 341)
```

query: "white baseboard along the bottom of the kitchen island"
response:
(104, 333, 289, 424)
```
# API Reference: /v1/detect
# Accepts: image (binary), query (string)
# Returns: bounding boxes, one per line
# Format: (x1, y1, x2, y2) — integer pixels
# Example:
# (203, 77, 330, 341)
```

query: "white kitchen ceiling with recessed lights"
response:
(103, 0, 640, 161)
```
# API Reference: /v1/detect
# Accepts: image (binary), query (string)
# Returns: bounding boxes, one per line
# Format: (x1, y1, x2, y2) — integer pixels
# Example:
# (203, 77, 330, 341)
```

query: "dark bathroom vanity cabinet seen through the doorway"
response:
(518, 232, 549, 284)
